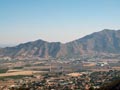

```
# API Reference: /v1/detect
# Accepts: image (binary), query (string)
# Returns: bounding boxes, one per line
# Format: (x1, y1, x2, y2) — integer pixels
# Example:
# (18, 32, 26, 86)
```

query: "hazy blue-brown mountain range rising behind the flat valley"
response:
(0, 29, 120, 59)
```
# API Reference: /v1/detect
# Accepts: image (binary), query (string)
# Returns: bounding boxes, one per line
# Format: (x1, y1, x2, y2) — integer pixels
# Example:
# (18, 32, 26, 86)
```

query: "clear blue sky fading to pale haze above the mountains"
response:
(0, 0, 120, 44)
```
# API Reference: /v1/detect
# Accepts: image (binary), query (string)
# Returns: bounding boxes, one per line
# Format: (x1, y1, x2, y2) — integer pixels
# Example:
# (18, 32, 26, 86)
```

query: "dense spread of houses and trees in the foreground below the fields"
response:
(0, 70, 120, 90)
